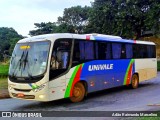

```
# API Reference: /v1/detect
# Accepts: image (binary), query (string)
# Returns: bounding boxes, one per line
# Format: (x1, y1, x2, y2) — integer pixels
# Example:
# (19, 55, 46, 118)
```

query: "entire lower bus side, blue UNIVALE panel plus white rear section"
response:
(65, 58, 157, 97)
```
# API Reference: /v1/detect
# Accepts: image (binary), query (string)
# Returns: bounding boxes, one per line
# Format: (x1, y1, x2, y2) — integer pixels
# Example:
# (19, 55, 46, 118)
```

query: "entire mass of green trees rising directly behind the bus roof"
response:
(29, 0, 160, 39)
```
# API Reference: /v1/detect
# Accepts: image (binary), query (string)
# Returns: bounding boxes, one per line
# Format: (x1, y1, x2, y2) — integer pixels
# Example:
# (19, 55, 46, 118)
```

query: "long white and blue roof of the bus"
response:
(18, 33, 155, 45)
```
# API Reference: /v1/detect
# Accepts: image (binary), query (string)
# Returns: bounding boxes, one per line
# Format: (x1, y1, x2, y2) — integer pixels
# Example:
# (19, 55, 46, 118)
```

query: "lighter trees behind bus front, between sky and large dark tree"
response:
(29, 6, 90, 36)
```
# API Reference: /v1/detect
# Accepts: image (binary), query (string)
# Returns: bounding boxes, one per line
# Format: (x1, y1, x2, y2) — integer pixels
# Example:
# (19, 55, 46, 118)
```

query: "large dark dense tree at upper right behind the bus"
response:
(86, 0, 160, 39)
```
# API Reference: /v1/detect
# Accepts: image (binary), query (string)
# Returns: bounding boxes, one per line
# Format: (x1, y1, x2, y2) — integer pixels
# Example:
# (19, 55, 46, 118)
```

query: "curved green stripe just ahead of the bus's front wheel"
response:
(64, 65, 80, 98)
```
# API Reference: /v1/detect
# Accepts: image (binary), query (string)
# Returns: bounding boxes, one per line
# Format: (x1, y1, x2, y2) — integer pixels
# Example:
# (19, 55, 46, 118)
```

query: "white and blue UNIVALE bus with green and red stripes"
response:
(8, 33, 157, 102)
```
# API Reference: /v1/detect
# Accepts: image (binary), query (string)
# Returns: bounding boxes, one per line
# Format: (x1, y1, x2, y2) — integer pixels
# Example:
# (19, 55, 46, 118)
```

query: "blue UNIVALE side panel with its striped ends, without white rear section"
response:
(65, 59, 135, 97)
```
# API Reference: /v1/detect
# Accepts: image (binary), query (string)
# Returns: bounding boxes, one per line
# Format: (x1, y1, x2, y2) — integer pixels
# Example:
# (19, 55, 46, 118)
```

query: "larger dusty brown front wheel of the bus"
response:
(70, 82, 86, 102)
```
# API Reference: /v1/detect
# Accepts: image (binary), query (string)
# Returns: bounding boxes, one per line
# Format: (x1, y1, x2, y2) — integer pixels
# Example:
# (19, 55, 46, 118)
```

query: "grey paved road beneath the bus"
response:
(0, 72, 160, 114)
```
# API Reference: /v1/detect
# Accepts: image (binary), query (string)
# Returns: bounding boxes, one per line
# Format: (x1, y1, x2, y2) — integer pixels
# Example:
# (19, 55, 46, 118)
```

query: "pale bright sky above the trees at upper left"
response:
(0, 0, 94, 36)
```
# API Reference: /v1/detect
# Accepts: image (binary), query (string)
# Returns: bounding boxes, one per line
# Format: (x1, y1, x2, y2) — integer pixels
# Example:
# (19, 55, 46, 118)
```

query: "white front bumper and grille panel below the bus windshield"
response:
(8, 76, 49, 101)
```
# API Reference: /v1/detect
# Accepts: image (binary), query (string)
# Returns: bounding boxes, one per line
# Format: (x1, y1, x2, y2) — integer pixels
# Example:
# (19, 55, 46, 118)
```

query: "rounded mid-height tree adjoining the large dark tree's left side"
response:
(58, 6, 91, 33)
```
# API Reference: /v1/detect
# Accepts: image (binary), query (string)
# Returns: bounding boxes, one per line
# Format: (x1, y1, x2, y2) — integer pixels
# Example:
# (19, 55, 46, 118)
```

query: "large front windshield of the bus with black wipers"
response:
(9, 41, 50, 77)
